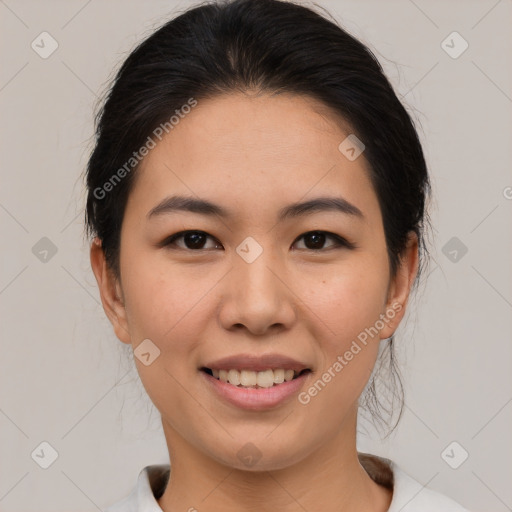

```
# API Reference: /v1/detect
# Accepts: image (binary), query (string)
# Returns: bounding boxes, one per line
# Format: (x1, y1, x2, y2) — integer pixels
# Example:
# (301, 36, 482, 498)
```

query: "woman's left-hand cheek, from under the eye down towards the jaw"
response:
(123, 257, 221, 416)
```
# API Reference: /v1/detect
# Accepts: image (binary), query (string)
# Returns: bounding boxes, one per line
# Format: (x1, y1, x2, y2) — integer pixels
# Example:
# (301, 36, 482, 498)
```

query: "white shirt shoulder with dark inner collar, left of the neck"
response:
(105, 464, 170, 512)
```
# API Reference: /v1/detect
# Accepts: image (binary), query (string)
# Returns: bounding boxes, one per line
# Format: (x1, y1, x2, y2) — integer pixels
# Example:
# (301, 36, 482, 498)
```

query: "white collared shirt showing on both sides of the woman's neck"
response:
(105, 454, 469, 512)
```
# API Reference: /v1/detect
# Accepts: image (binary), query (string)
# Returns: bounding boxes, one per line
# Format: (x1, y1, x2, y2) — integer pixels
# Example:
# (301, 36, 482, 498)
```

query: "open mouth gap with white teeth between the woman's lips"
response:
(200, 367, 311, 389)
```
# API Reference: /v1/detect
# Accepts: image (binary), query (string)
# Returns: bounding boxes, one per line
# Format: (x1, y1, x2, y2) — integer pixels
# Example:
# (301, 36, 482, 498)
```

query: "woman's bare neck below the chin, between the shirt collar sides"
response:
(158, 415, 392, 512)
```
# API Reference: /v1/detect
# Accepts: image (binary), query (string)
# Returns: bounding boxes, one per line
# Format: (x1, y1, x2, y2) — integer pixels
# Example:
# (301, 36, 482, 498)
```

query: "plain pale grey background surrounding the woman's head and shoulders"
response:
(0, 0, 512, 512)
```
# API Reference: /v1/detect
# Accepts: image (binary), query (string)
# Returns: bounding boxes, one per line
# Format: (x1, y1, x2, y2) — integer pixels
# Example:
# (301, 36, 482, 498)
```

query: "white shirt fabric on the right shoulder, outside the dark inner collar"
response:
(388, 461, 469, 512)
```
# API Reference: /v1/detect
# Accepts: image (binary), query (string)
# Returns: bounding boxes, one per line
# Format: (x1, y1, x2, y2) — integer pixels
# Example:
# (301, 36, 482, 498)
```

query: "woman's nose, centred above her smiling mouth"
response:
(218, 250, 297, 336)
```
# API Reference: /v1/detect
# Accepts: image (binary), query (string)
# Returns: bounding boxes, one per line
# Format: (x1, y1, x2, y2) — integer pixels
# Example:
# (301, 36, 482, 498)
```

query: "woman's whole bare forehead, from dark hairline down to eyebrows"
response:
(125, 93, 376, 224)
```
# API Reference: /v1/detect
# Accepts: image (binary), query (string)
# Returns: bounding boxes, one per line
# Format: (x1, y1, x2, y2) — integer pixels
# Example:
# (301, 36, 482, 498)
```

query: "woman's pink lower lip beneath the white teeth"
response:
(200, 370, 311, 411)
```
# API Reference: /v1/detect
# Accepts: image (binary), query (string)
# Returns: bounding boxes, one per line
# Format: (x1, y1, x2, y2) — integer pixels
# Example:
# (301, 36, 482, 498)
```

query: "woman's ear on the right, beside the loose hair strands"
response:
(380, 231, 419, 339)
